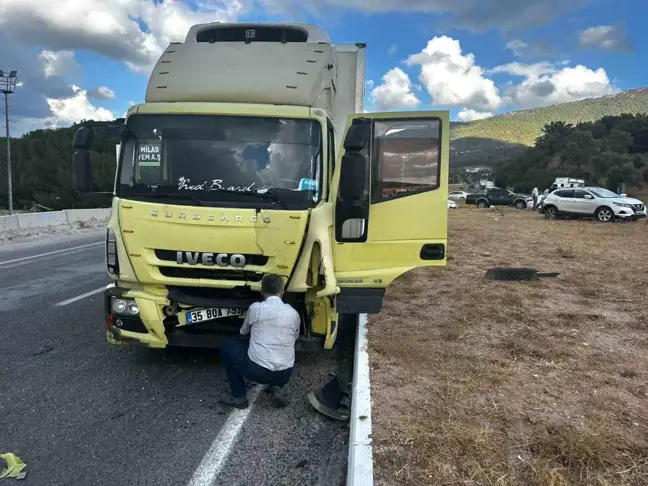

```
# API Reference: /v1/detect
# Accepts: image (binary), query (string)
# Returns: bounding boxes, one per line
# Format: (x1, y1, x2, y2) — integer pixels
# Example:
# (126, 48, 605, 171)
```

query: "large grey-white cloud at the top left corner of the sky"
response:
(0, 0, 251, 71)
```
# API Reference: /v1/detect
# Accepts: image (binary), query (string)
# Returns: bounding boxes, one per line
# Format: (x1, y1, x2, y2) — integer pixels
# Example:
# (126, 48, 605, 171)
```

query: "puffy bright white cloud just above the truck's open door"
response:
(405, 36, 502, 113)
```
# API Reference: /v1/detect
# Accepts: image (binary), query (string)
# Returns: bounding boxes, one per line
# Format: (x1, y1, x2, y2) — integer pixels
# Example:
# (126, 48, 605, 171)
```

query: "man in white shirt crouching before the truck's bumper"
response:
(220, 275, 301, 408)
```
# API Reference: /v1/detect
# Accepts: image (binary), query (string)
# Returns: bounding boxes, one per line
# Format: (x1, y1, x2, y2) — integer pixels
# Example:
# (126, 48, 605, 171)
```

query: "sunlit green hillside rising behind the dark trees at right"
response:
(450, 88, 648, 167)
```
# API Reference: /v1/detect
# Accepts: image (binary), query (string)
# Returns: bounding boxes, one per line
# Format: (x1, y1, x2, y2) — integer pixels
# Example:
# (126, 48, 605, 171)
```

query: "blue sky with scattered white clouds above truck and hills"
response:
(0, 0, 648, 136)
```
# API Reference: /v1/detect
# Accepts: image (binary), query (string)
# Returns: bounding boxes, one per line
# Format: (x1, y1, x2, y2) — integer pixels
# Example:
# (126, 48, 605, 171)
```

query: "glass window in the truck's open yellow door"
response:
(371, 119, 441, 203)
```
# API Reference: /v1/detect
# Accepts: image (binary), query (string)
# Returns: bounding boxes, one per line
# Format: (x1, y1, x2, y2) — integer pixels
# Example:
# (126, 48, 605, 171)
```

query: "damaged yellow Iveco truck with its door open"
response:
(73, 23, 449, 350)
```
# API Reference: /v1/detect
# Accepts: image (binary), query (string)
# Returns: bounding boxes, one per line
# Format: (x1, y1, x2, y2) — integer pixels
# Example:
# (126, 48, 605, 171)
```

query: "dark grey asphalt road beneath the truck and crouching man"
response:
(0, 232, 350, 486)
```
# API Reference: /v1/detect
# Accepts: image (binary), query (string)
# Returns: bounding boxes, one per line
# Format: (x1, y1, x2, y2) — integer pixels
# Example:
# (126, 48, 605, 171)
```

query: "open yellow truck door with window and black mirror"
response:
(332, 111, 450, 314)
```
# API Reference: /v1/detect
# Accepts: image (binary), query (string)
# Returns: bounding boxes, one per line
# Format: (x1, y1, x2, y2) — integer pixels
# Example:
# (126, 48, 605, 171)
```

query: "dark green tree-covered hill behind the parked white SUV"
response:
(496, 114, 648, 191)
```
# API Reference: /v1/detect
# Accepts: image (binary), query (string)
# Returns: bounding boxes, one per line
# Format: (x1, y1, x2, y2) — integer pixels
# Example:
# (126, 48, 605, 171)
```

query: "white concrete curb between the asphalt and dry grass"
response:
(347, 314, 373, 486)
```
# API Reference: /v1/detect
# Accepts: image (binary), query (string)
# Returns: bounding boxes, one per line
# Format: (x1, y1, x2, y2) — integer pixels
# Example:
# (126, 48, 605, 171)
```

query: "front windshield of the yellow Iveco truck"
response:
(117, 115, 322, 207)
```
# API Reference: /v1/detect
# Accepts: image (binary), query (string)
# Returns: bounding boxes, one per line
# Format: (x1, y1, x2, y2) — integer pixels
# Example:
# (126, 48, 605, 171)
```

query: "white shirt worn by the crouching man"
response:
(241, 297, 301, 371)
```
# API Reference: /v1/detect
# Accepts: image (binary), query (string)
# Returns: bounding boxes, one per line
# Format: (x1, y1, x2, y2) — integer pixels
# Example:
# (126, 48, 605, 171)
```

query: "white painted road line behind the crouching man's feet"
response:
(189, 385, 265, 486)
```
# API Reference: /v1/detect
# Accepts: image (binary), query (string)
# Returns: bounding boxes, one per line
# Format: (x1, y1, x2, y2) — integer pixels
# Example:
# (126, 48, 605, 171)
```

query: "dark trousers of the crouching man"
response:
(221, 339, 293, 398)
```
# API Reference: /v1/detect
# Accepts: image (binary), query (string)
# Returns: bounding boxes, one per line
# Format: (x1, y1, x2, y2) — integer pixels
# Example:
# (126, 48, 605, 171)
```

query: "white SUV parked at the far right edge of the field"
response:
(542, 187, 646, 223)
